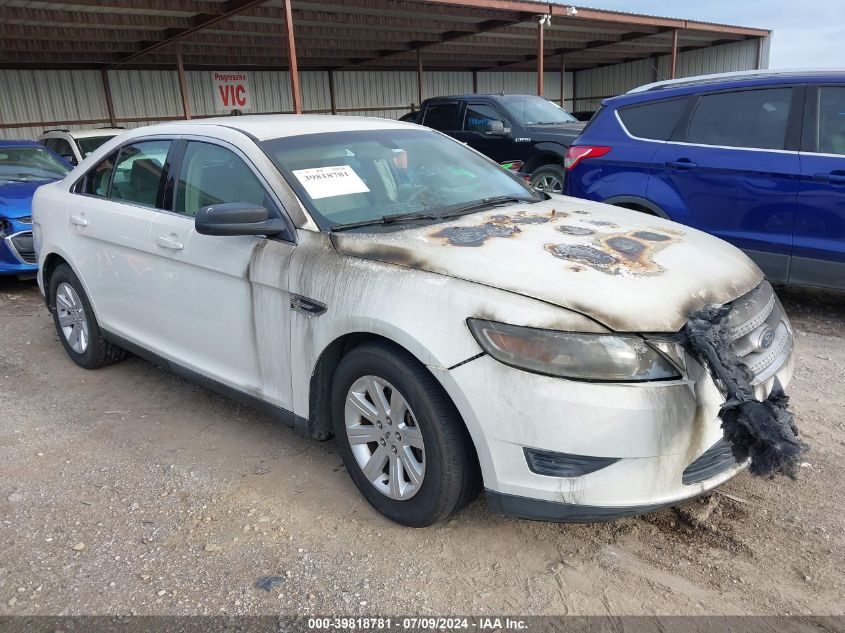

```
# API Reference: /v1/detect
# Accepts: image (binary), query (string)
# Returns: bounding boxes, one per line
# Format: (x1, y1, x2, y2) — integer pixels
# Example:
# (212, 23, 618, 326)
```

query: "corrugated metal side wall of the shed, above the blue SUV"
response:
(575, 38, 769, 110)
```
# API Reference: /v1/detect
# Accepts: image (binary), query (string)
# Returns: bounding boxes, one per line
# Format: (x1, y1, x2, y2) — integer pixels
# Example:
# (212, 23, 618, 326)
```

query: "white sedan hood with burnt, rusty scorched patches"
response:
(332, 197, 763, 332)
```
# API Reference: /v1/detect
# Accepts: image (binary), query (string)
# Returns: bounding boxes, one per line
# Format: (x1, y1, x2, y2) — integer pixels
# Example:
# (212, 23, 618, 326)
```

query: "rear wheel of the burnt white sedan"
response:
(48, 264, 126, 369)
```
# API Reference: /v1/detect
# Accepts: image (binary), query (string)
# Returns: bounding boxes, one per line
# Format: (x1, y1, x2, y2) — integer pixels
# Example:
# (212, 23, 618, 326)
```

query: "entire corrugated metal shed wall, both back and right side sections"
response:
(0, 40, 769, 138)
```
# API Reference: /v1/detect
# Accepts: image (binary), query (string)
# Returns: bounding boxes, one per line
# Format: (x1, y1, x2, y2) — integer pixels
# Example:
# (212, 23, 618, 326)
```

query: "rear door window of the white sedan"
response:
(109, 141, 171, 208)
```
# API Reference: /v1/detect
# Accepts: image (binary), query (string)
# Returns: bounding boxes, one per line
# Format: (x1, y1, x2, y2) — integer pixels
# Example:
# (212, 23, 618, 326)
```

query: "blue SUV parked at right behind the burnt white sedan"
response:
(566, 71, 845, 289)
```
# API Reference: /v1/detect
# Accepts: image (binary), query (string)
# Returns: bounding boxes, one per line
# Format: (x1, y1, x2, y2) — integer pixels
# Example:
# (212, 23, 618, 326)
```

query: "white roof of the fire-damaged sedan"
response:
(124, 114, 421, 141)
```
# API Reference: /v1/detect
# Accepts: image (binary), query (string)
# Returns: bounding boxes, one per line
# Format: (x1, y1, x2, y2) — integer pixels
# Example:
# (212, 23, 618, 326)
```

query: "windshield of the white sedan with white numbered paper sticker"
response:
(261, 129, 537, 229)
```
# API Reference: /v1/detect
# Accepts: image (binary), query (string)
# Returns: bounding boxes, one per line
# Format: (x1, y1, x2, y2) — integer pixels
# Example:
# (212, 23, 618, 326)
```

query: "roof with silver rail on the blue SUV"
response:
(602, 69, 845, 107)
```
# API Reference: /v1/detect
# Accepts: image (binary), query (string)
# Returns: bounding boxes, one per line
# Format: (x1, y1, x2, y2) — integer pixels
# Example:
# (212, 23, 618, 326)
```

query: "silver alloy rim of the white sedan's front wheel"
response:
(344, 376, 425, 501)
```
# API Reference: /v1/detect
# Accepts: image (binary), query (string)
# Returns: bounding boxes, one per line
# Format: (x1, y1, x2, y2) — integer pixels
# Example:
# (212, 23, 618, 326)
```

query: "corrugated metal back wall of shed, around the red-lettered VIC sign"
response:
(0, 70, 572, 139)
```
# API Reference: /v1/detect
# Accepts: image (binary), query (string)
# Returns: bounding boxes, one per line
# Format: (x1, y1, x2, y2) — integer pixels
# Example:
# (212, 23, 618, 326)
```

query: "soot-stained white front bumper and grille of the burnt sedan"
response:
(432, 280, 794, 522)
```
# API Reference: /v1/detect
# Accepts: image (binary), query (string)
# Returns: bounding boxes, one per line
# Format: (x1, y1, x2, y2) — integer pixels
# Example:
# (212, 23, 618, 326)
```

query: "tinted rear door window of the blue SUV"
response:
(686, 88, 792, 149)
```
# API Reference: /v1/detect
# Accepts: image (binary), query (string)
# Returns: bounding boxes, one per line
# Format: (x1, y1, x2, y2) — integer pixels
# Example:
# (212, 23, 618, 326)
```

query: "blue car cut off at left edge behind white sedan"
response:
(0, 141, 73, 278)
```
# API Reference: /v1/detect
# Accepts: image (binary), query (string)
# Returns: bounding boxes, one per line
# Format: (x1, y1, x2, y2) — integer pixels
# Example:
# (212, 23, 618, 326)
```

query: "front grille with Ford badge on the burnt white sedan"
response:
(728, 281, 793, 386)
